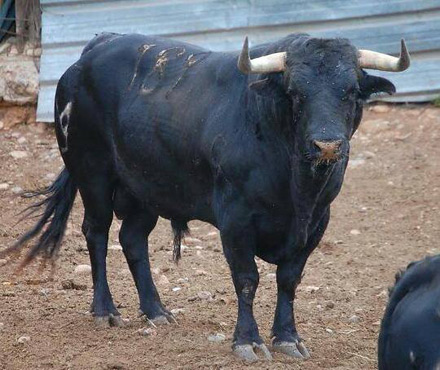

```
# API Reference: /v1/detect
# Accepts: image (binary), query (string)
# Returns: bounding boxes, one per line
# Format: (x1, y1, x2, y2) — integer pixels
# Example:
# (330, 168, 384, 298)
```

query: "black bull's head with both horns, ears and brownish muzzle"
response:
(238, 35, 410, 164)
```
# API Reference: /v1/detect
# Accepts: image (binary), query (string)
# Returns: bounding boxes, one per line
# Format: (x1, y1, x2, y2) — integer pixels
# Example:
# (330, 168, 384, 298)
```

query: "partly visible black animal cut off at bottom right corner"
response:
(379, 256, 440, 370)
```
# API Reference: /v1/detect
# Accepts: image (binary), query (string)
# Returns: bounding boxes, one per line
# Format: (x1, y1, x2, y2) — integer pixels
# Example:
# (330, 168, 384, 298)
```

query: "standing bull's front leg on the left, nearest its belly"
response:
(221, 228, 272, 361)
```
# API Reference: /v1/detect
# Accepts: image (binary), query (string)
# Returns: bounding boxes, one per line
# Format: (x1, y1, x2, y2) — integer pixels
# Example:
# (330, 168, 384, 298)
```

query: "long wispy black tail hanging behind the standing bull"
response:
(0, 168, 77, 267)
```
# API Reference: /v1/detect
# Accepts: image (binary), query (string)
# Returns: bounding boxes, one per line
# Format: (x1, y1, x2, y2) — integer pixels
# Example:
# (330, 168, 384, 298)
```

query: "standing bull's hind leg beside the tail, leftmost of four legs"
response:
(79, 181, 123, 326)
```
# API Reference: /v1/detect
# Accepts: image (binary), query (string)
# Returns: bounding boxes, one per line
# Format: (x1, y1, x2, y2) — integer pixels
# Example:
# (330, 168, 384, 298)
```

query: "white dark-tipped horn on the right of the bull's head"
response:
(359, 39, 411, 72)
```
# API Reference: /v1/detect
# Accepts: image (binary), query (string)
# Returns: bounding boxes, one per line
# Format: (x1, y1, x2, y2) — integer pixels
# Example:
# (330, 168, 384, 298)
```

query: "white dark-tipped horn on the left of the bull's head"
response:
(237, 36, 286, 74)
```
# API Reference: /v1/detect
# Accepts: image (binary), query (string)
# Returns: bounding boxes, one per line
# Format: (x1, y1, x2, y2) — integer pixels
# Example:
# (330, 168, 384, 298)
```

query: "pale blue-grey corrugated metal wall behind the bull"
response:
(37, 0, 440, 121)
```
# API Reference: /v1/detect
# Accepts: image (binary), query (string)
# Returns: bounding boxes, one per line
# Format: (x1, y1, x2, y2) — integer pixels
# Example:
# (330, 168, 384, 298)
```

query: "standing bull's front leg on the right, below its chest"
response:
(272, 211, 330, 359)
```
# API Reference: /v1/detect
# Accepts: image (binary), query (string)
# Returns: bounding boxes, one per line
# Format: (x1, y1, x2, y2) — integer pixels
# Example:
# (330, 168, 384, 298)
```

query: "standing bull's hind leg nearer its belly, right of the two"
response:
(119, 210, 174, 324)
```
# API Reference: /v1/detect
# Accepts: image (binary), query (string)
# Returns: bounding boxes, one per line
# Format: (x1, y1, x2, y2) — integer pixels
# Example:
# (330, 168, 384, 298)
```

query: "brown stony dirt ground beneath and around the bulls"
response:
(0, 105, 440, 370)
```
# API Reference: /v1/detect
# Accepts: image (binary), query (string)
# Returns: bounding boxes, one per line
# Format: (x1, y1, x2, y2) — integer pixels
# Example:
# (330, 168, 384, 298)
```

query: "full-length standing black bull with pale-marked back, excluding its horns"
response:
(2, 34, 410, 360)
